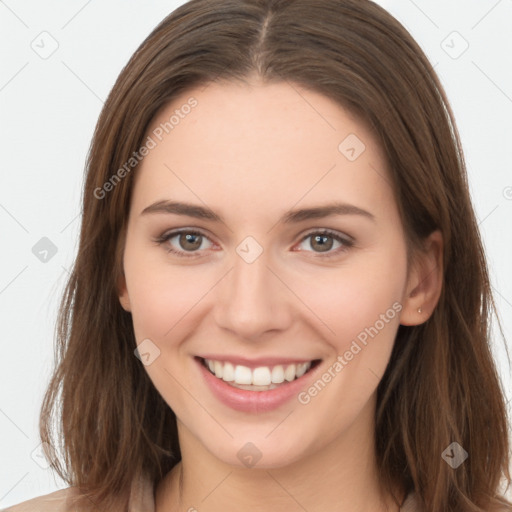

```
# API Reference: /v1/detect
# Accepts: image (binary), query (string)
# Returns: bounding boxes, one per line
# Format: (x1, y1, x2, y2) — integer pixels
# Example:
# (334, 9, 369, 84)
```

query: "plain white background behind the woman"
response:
(0, 0, 512, 508)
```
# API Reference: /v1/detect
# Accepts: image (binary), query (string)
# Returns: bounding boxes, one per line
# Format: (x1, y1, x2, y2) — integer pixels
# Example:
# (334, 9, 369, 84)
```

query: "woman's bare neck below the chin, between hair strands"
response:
(156, 400, 399, 512)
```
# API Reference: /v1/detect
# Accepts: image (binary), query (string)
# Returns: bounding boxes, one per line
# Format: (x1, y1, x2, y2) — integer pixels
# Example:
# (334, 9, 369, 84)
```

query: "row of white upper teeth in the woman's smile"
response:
(204, 359, 311, 386)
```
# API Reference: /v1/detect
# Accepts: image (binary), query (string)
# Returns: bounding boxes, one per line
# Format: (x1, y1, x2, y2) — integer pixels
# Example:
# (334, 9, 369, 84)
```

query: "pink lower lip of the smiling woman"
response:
(196, 358, 319, 413)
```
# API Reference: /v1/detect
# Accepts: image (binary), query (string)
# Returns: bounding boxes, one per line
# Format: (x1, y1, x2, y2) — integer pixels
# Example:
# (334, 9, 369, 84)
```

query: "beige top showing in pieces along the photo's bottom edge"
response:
(0, 477, 419, 512)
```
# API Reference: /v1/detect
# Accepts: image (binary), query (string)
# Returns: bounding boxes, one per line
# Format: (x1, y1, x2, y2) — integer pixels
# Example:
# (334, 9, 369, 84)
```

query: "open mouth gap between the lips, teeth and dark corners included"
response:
(197, 357, 321, 392)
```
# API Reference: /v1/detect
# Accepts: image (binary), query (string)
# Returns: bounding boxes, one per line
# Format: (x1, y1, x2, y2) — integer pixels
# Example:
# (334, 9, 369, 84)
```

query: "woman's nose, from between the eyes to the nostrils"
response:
(214, 247, 296, 341)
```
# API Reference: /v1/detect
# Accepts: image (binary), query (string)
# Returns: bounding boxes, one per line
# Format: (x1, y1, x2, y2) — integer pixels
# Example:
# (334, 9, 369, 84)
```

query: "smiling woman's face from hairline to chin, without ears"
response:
(120, 79, 424, 467)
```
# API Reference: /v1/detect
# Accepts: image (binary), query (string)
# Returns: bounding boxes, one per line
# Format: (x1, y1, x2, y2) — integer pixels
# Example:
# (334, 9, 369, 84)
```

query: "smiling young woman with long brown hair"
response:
(5, 0, 511, 512)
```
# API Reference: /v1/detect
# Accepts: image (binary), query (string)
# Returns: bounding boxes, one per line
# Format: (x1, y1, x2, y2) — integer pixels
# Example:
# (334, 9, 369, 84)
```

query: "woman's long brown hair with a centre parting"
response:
(40, 0, 510, 512)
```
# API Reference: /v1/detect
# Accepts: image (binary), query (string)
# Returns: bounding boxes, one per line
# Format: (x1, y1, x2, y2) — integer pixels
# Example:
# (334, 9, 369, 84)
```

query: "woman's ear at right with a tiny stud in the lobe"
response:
(400, 230, 443, 325)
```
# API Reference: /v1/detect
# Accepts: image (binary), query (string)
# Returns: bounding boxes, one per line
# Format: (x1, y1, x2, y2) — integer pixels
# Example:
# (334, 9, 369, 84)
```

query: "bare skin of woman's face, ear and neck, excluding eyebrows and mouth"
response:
(119, 79, 443, 512)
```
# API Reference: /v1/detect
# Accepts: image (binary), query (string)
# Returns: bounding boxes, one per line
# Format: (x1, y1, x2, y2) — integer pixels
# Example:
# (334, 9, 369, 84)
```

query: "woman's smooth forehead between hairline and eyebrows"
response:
(131, 82, 393, 221)
